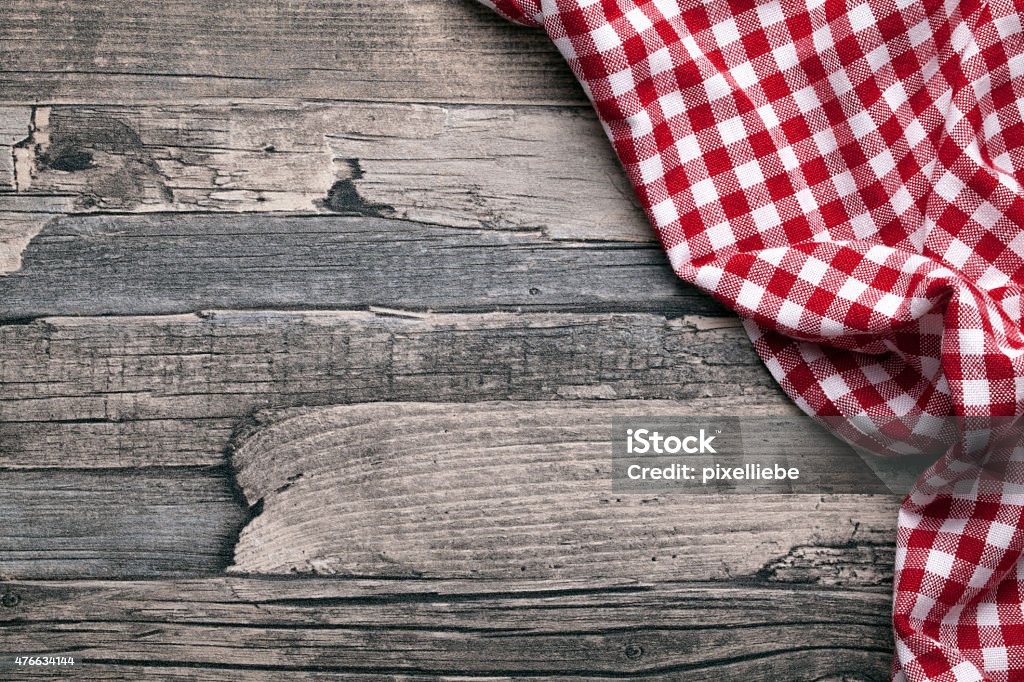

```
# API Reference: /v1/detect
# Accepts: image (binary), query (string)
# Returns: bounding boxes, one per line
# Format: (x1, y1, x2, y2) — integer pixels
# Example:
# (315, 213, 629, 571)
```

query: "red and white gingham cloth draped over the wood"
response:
(481, 0, 1024, 681)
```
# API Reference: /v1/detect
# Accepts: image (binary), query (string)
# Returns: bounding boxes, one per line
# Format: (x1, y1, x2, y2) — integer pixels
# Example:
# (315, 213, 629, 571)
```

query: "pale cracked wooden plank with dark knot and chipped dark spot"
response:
(22, 102, 654, 242)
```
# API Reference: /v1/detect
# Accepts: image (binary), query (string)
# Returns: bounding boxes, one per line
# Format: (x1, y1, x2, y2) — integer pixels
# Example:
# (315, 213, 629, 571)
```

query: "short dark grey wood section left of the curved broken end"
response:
(0, 468, 245, 573)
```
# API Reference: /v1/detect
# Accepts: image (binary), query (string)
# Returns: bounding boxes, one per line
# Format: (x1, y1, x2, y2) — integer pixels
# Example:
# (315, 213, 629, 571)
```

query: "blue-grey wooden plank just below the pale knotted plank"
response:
(0, 214, 724, 321)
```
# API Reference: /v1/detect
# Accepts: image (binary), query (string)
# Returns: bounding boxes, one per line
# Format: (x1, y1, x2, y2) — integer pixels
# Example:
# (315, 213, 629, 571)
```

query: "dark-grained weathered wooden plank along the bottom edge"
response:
(0, 579, 892, 681)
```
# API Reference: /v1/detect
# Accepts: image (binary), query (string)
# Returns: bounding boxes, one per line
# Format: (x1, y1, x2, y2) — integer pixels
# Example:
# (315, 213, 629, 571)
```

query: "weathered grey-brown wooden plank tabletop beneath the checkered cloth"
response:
(0, 0, 899, 680)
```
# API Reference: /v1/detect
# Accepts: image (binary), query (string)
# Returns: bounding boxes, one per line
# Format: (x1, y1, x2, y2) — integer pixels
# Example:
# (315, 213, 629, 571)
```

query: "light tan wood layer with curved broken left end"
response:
(231, 400, 899, 581)
